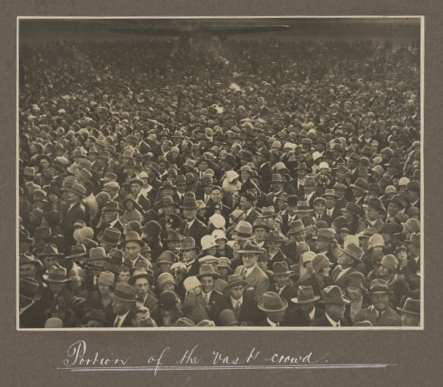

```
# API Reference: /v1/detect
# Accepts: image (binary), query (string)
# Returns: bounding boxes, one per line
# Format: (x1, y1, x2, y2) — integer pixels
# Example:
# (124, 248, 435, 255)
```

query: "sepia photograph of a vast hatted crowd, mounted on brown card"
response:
(15, 17, 424, 330)
